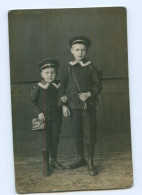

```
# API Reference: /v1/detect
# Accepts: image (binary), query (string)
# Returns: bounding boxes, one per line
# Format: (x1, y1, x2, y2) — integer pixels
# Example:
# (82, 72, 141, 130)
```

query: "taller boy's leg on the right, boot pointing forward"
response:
(82, 111, 97, 176)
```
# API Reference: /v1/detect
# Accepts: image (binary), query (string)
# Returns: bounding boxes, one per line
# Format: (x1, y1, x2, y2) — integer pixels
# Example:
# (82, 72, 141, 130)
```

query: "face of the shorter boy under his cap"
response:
(41, 68, 56, 83)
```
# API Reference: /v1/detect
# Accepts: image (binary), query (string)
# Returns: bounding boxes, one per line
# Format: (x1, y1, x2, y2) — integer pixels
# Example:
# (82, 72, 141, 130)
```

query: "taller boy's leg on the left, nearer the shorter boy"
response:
(69, 109, 86, 169)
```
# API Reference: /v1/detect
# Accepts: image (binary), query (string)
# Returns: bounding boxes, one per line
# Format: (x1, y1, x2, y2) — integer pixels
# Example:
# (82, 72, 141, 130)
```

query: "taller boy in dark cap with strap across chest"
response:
(59, 36, 102, 176)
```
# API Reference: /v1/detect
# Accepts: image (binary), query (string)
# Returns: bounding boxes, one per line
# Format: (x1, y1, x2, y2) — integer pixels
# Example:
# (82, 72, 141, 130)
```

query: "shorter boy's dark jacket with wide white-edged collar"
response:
(31, 80, 61, 120)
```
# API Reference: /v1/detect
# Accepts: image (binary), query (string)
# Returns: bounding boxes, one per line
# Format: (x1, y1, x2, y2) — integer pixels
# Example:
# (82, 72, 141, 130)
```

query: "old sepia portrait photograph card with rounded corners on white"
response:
(8, 7, 133, 193)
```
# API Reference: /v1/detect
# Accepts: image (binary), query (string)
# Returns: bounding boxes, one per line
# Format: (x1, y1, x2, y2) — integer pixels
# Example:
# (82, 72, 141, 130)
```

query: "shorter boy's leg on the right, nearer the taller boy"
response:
(51, 121, 64, 170)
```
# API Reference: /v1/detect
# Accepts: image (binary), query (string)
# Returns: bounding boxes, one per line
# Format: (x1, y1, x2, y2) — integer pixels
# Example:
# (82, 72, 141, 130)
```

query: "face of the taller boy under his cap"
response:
(71, 43, 87, 61)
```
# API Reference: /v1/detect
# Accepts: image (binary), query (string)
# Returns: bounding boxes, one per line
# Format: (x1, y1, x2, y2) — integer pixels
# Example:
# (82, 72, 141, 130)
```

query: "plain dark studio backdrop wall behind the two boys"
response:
(9, 8, 131, 157)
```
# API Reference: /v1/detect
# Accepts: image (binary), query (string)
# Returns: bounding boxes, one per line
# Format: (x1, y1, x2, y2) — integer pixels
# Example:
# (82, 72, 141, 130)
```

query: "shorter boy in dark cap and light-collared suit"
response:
(31, 58, 64, 176)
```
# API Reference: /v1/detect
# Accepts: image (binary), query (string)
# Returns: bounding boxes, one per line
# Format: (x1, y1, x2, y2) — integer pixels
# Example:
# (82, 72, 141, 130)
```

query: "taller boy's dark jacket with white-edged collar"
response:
(59, 59, 102, 109)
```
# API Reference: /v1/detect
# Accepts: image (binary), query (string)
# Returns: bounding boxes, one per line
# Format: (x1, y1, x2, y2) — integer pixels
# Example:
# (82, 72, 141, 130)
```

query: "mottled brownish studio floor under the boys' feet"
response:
(15, 153, 133, 193)
